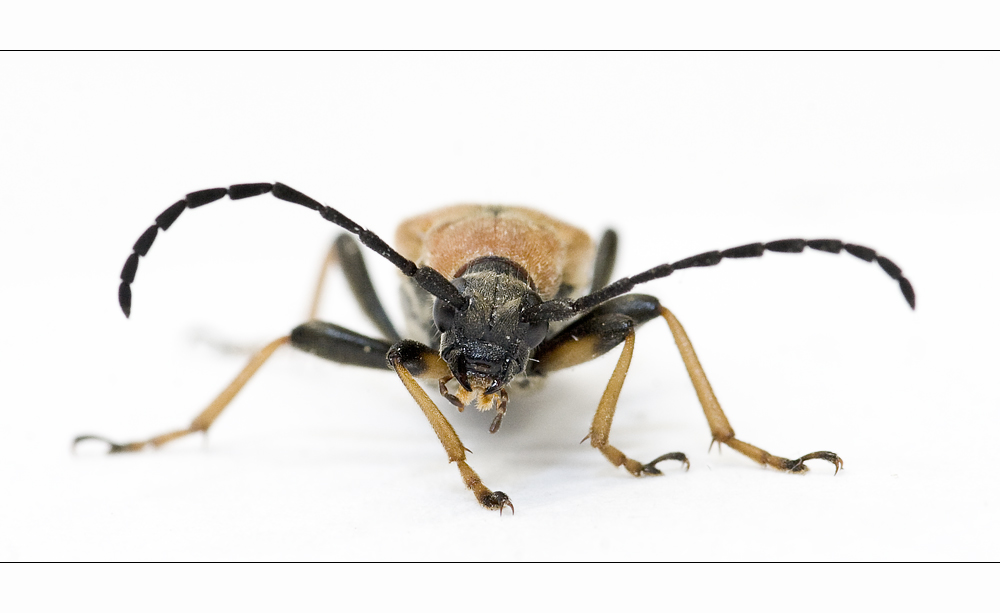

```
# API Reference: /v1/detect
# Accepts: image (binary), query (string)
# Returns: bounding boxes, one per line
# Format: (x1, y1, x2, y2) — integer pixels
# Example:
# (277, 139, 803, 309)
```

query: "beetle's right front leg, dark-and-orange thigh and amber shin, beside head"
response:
(533, 294, 690, 477)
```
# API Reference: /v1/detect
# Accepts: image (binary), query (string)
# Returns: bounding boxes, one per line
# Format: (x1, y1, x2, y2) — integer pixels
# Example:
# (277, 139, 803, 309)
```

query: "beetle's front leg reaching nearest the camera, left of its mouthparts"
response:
(387, 340, 514, 515)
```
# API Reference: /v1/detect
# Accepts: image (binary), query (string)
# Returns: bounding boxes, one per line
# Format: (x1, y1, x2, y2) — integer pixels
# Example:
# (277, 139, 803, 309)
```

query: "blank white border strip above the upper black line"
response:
(0, 0, 997, 50)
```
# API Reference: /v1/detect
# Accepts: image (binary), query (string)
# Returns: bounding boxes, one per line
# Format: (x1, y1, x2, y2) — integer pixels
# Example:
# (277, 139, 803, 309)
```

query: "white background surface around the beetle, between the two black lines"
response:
(0, 55, 1000, 560)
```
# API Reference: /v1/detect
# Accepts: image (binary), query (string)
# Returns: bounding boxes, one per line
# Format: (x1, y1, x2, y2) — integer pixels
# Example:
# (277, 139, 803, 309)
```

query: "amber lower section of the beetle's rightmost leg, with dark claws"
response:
(660, 306, 844, 474)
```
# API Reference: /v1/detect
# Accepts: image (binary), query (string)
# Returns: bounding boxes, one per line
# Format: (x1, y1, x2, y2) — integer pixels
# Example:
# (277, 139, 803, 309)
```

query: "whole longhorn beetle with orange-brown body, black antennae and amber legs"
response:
(74, 183, 916, 514)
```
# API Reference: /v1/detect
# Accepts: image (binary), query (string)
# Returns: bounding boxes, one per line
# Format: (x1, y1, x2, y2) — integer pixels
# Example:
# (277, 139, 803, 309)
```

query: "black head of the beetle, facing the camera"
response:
(434, 257, 549, 395)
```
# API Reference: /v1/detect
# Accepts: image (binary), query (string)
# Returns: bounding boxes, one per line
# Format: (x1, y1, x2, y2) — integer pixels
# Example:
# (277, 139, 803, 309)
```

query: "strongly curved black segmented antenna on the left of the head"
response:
(118, 183, 467, 317)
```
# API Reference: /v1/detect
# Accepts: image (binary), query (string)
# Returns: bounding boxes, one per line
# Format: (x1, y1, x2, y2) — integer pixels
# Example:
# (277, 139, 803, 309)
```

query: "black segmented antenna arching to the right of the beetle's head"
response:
(521, 238, 917, 322)
